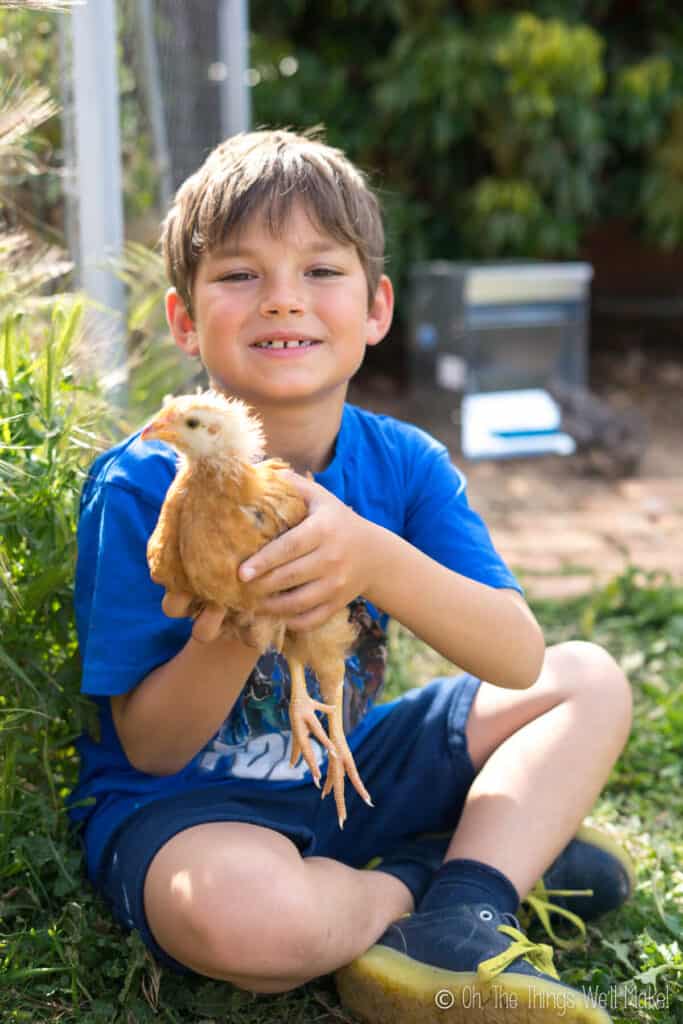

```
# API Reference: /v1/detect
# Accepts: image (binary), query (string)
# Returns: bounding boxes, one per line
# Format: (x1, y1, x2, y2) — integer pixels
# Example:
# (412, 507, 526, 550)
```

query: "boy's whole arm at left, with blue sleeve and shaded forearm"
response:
(76, 471, 258, 775)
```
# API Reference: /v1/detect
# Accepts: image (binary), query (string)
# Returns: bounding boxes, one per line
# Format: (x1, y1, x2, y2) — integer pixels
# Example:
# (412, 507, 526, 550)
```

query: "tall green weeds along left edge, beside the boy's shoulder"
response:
(0, 296, 106, 839)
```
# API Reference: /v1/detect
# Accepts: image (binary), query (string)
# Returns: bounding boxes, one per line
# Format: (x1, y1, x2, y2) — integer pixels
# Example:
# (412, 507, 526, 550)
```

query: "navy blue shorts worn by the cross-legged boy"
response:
(97, 676, 480, 973)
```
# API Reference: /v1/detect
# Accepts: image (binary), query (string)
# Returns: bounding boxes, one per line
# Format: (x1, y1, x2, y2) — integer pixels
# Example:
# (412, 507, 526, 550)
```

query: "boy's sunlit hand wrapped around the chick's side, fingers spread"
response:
(239, 471, 377, 631)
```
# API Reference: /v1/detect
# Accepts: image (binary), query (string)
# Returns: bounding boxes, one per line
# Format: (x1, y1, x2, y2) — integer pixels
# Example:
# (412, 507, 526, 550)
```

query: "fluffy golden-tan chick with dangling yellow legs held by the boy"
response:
(140, 391, 372, 828)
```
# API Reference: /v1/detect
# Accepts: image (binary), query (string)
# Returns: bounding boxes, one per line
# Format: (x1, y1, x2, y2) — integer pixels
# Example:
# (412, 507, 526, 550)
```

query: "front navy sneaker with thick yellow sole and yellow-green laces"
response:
(335, 903, 610, 1024)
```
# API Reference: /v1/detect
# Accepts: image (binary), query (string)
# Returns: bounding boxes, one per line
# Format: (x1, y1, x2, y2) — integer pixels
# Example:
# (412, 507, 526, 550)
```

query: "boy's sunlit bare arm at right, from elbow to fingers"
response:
(240, 477, 545, 689)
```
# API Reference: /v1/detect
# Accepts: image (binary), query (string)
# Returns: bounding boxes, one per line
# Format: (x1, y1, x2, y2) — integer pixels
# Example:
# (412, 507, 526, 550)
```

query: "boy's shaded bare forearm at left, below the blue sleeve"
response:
(111, 615, 258, 775)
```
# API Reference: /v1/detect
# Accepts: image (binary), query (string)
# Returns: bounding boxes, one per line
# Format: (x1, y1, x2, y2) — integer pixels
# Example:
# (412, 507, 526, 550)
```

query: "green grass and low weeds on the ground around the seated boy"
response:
(0, 570, 683, 1024)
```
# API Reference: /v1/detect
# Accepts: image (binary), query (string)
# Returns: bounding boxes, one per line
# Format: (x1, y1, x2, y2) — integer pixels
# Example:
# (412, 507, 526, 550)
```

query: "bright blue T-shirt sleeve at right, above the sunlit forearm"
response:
(404, 438, 523, 594)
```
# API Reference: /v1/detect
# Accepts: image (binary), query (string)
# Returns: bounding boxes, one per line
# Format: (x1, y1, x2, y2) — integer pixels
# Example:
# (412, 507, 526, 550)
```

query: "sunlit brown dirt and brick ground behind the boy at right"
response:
(349, 339, 683, 597)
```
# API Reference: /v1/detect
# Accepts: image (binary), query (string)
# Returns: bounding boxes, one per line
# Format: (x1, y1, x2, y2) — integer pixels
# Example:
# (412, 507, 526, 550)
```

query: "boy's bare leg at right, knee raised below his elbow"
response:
(445, 642, 631, 898)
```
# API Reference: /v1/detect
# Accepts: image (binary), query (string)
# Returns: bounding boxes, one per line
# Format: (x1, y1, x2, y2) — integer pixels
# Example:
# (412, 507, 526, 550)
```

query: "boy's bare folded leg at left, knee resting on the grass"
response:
(144, 822, 413, 992)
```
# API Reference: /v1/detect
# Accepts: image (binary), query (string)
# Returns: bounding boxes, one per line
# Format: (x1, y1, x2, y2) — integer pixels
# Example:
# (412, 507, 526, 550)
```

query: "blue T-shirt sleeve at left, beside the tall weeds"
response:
(76, 483, 191, 696)
